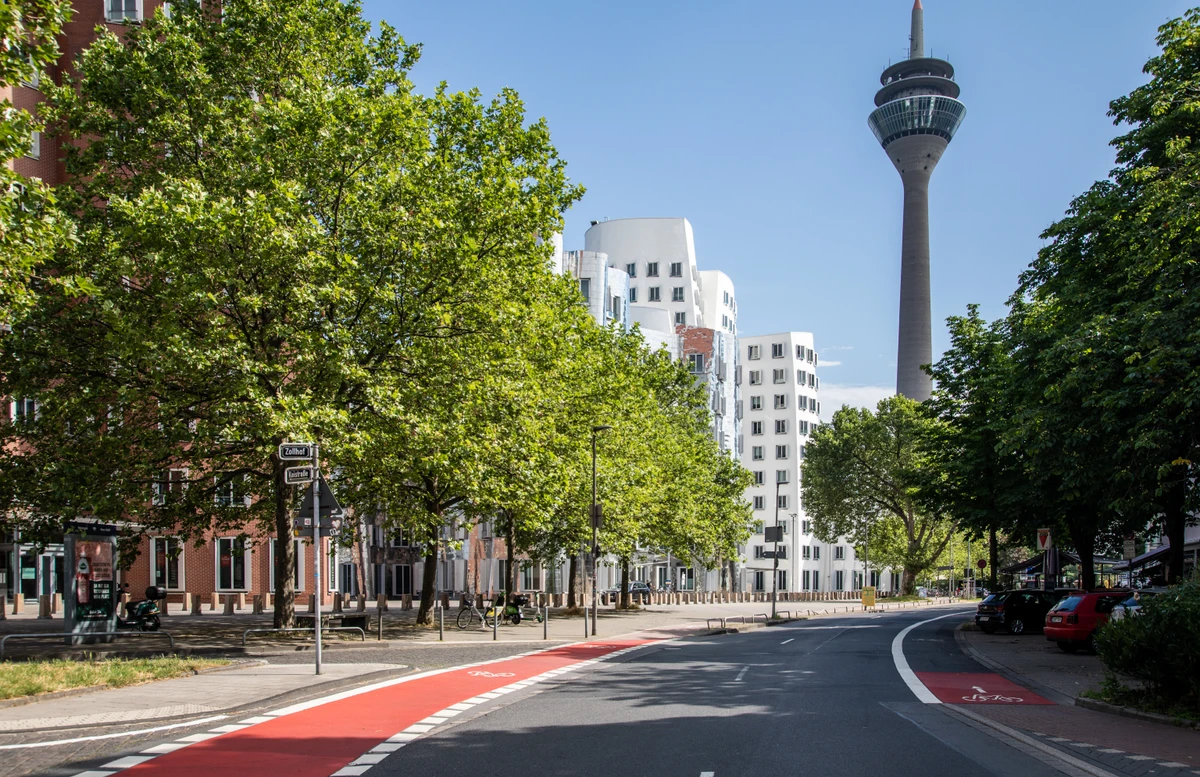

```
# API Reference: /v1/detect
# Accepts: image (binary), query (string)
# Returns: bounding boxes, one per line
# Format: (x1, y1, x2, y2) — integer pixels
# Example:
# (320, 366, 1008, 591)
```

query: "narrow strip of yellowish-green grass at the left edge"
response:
(0, 656, 229, 699)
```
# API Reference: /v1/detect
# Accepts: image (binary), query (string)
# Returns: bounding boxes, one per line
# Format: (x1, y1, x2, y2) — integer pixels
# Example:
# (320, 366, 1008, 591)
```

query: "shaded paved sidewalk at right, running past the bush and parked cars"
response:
(955, 628, 1200, 777)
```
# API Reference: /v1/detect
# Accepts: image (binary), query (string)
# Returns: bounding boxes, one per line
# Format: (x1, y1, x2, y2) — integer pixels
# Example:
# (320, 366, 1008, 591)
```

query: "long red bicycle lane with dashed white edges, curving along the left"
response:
(97, 639, 664, 777)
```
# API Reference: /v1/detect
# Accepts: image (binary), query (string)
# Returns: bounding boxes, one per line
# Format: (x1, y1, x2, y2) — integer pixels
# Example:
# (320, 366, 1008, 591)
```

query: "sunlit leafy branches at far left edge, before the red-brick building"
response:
(0, 0, 77, 324)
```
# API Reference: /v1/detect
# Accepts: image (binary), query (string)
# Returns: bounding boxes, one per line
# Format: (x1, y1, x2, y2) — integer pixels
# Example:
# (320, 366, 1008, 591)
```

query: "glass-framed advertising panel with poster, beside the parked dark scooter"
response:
(64, 525, 118, 645)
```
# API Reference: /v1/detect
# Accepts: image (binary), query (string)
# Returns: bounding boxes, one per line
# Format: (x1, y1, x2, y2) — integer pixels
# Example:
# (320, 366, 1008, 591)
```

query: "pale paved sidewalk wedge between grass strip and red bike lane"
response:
(0, 663, 404, 734)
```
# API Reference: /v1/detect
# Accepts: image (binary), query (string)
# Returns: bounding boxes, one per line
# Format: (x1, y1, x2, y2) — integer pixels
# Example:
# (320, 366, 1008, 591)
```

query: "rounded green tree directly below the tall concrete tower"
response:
(803, 397, 956, 594)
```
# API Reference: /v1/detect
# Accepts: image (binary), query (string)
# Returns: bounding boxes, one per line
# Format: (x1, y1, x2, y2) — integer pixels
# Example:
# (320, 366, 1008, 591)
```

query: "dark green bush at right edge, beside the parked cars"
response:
(1096, 580, 1200, 711)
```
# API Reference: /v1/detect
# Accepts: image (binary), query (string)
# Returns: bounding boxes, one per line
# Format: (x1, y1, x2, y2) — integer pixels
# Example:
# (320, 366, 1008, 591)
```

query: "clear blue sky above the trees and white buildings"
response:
(362, 0, 1195, 417)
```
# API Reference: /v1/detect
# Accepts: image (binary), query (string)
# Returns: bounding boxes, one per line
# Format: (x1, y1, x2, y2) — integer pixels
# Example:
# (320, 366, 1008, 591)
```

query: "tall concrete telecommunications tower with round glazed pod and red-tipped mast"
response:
(869, 0, 967, 402)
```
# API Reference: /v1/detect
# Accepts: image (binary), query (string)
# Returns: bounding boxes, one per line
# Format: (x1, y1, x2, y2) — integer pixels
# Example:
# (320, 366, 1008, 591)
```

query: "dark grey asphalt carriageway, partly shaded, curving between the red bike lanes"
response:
(368, 613, 1062, 777)
